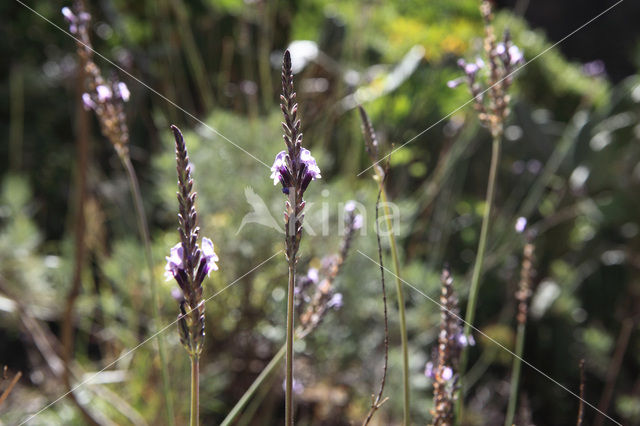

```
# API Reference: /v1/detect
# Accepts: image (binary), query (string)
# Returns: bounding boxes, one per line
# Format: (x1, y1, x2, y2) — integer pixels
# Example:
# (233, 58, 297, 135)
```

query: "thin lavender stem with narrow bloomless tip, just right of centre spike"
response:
(358, 107, 411, 426)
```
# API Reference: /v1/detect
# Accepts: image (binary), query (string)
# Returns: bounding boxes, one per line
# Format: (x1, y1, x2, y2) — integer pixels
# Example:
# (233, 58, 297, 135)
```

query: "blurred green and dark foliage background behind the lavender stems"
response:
(0, 0, 640, 425)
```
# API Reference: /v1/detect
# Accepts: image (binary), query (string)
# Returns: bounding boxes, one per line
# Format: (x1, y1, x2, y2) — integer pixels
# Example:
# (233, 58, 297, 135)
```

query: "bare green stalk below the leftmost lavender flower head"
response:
(120, 155, 175, 426)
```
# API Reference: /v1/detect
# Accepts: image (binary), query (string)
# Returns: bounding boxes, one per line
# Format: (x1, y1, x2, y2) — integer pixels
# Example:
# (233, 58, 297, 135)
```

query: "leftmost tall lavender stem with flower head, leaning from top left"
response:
(61, 0, 174, 426)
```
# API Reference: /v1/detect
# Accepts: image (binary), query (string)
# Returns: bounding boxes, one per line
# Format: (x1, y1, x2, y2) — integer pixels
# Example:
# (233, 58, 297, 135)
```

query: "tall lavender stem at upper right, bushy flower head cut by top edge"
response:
(448, 0, 524, 418)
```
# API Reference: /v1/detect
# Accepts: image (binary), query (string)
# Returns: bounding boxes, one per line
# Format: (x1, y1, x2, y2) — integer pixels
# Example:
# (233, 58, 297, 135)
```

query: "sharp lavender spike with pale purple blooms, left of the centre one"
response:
(165, 126, 218, 426)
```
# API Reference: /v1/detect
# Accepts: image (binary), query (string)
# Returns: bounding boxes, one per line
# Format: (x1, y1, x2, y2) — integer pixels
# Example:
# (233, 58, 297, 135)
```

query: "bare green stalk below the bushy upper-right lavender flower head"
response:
(456, 135, 500, 422)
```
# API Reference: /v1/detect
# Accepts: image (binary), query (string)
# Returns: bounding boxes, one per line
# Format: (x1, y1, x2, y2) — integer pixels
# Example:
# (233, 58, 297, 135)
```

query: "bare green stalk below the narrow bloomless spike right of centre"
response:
(378, 181, 410, 426)
